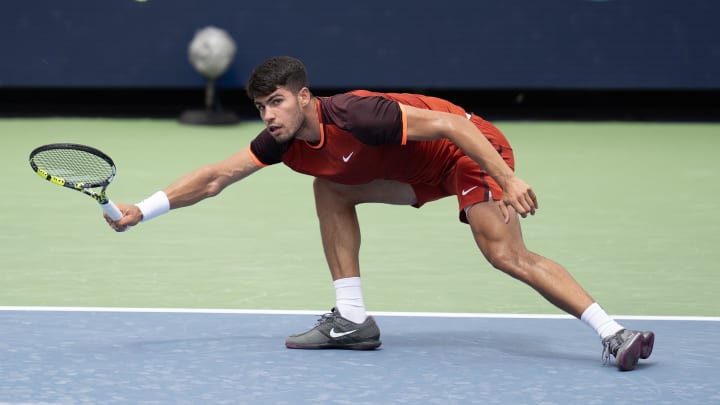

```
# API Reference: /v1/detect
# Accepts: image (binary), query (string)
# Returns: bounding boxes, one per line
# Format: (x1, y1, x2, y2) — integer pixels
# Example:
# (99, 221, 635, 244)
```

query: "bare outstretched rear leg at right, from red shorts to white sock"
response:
(467, 201, 594, 318)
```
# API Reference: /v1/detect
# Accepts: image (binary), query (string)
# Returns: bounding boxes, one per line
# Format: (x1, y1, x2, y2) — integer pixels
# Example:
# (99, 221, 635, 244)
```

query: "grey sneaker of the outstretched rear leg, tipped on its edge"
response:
(602, 329, 655, 371)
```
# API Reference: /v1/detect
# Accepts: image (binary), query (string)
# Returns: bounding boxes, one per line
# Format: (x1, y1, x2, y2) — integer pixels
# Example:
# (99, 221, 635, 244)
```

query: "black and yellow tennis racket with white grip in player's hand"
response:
(30, 143, 123, 221)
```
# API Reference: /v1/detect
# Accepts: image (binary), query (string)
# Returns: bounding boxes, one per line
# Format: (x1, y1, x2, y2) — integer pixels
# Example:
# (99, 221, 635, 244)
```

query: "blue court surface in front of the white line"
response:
(0, 309, 720, 404)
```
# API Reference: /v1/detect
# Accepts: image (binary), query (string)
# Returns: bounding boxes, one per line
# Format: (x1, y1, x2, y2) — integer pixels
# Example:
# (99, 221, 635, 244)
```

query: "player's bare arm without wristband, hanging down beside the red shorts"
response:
(403, 105, 538, 222)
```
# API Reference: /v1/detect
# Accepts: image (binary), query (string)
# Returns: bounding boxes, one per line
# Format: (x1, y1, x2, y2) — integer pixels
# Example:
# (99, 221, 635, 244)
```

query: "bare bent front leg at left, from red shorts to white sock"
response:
(313, 179, 416, 280)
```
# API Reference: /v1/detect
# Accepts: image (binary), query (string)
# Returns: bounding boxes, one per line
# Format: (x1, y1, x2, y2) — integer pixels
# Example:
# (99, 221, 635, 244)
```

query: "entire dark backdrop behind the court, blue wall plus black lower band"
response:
(0, 0, 720, 120)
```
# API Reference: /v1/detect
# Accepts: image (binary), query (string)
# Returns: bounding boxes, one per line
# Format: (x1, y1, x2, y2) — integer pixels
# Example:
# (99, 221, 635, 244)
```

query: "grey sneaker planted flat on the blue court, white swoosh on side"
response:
(285, 308, 382, 350)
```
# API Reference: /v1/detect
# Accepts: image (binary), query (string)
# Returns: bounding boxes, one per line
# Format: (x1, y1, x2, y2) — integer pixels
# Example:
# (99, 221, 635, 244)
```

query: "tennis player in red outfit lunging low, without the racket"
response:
(106, 56, 654, 370)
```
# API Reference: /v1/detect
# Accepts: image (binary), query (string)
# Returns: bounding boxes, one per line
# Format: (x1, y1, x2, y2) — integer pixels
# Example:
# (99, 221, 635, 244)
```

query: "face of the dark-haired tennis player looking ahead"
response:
(255, 87, 305, 143)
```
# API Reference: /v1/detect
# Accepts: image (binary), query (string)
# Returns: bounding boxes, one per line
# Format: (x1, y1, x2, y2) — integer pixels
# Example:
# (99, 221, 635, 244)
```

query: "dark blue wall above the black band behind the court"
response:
(0, 0, 720, 89)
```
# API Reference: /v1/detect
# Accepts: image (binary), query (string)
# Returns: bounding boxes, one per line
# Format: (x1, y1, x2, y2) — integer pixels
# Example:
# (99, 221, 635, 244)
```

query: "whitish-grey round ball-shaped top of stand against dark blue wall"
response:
(188, 26, 235, 79)
